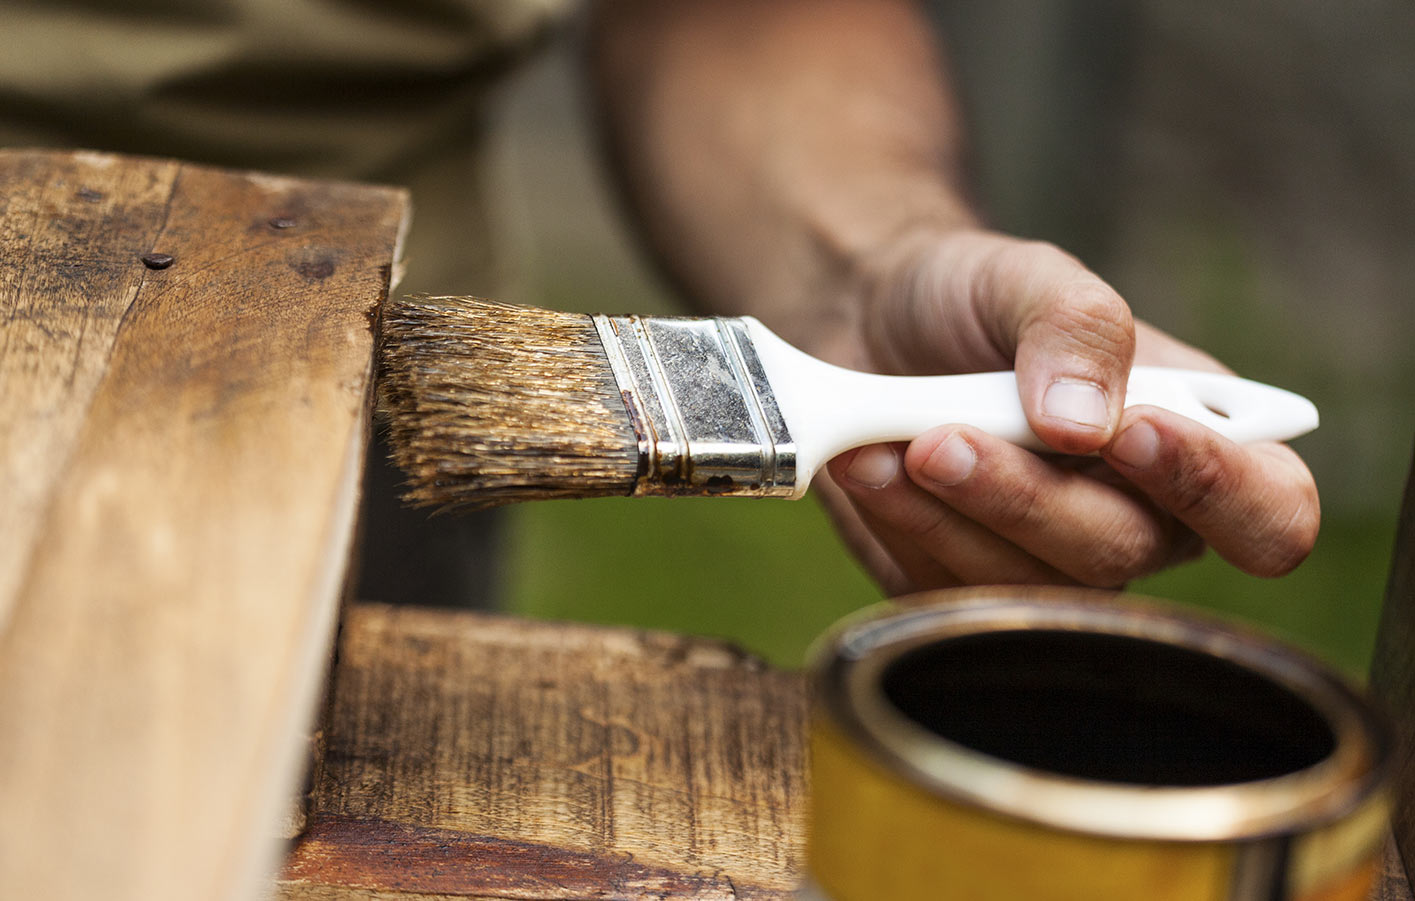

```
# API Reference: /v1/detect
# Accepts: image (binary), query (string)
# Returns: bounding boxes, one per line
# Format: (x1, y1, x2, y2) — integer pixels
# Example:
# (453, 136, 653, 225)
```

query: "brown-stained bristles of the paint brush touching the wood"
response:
(381, 296, 638, 509)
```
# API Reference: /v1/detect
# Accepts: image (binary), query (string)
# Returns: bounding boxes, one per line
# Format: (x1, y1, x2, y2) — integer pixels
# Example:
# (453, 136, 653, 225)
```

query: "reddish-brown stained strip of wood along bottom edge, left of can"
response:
(282, 816, 751, 901)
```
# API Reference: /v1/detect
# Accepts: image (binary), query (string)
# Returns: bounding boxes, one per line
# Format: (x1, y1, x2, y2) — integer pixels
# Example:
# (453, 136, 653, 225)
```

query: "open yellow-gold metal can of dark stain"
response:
(799, 588, 1391, 901)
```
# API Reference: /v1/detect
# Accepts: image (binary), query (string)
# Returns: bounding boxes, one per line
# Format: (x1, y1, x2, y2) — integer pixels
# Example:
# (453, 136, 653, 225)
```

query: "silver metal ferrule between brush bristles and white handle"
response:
(591, 315, 795, 496)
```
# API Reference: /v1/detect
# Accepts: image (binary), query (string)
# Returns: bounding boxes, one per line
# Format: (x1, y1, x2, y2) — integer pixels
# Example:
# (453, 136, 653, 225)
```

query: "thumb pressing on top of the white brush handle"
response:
(985, 242, 1135, 454)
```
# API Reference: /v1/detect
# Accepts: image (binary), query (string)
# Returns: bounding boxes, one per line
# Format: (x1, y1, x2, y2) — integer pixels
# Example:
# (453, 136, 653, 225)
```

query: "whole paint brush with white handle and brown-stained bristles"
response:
(381, 296, 1317, 509)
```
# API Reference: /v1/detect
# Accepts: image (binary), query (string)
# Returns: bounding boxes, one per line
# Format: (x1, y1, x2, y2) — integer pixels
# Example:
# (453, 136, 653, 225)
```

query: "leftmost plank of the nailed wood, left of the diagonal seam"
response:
(0, 153, 178, 625)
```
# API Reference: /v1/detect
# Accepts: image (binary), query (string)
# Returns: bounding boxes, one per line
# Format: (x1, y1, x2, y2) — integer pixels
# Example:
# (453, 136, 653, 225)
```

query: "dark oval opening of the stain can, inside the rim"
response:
(882, 629, 1336, 786)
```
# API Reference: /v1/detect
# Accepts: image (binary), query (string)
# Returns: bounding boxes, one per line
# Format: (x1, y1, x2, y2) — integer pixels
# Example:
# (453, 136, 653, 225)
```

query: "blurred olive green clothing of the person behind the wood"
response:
(0, 0, 572, 293)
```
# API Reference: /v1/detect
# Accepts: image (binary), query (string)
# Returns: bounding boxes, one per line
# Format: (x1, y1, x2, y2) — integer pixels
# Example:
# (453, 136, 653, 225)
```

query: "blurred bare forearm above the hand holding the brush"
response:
(590, 0, 971, 357)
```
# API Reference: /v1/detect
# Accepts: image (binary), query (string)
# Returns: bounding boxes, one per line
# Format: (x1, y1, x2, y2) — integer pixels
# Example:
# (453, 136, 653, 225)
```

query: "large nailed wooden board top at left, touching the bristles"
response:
(0, 151, 406, 898)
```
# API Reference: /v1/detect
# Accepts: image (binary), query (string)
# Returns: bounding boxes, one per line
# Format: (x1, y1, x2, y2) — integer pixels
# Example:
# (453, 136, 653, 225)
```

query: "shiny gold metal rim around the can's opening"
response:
(814, 588, 1391, 842)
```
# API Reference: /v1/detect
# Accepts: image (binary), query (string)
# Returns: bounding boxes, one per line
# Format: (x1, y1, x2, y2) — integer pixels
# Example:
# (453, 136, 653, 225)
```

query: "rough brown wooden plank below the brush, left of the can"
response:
(279, 604, 805, 901)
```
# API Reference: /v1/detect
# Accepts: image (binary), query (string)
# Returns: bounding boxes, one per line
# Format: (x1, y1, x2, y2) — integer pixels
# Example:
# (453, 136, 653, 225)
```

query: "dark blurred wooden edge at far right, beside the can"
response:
(1371, 432, 1415, 893)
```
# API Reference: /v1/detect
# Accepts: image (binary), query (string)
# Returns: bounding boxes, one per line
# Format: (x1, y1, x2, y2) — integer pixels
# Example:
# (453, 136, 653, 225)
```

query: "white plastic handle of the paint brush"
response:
(743, 317, 1317, 494)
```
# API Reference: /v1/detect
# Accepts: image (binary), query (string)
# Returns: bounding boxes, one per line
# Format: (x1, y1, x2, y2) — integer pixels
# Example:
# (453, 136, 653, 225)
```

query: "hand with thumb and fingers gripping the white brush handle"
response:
(821, 229, 1320, 594)
